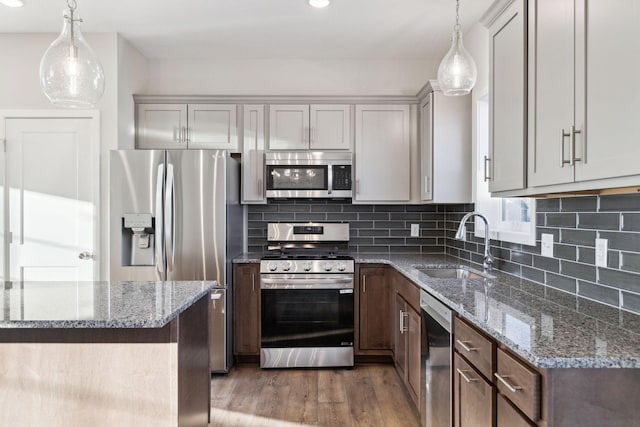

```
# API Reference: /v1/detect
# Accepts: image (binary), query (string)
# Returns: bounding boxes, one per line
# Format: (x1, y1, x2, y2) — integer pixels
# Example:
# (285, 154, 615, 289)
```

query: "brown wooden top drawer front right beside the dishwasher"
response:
(454, 317, 496, 381)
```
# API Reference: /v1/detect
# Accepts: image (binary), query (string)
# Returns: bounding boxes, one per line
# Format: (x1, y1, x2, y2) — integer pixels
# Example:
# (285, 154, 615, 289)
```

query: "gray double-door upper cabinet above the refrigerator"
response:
(136, 104, 238, 151)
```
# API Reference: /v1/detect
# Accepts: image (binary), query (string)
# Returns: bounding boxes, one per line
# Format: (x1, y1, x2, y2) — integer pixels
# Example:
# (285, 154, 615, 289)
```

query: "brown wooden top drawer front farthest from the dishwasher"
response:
(494, 349, 540, 421)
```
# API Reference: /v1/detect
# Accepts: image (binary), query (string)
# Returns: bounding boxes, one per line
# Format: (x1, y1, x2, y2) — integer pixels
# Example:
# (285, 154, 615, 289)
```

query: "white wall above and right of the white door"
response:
(0, 33, 146, 279)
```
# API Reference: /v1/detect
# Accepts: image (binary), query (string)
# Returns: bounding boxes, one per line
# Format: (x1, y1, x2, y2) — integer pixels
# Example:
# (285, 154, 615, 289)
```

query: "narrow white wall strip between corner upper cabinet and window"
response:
(464, 23, 489, 200)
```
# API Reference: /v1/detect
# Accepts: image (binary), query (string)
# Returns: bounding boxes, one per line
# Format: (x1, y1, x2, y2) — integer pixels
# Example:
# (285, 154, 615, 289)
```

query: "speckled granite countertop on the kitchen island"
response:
(0, 281, 217, 329)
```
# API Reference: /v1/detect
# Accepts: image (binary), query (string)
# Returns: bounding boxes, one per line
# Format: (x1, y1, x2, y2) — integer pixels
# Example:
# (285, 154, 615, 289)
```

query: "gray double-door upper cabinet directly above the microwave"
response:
(269, 104, 351, 150)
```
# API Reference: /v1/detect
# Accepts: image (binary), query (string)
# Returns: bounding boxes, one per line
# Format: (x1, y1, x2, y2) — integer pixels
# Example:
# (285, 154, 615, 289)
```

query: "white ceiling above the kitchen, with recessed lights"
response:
(0, 0, 493, 59)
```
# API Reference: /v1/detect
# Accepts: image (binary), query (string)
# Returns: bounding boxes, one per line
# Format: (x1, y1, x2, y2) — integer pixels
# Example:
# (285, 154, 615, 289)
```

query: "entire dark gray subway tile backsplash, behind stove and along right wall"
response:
(248, 194, 640, 313)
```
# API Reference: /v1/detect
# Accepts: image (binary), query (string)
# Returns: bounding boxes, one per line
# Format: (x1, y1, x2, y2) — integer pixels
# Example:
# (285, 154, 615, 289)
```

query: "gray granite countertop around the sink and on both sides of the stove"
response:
(234, 254, 640, 368)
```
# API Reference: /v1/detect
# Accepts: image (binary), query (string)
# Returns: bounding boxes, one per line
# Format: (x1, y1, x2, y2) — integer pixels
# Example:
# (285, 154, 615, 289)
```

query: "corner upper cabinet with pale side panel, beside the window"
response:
(419, 81, 472, 203)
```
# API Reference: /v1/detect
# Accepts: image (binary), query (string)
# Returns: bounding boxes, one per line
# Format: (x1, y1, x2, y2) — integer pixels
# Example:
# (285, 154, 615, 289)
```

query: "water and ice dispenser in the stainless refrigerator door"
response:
(122, 213, 156, 266)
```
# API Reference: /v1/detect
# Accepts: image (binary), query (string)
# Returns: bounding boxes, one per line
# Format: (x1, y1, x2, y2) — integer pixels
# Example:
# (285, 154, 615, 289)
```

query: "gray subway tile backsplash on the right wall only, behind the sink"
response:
(445, 194, 640, 313)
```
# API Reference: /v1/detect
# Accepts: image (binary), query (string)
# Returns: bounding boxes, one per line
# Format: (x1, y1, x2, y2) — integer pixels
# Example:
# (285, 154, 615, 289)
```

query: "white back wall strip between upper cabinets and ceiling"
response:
(146, 59, 439, 95)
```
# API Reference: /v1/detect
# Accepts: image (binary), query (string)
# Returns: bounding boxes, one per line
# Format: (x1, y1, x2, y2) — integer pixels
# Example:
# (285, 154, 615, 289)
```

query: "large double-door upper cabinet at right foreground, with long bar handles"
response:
(528, 0, 640, 190)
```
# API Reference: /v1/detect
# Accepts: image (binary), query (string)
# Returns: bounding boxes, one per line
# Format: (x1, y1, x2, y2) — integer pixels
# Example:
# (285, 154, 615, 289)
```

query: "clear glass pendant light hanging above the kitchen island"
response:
(40, 0, 104, 108)
